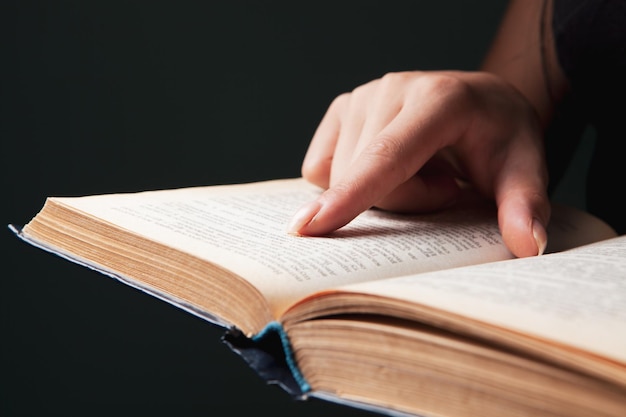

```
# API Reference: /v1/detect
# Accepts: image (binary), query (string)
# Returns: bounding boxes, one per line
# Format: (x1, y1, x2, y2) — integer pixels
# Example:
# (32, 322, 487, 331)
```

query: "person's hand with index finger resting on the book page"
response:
(289, 71, 550, 257)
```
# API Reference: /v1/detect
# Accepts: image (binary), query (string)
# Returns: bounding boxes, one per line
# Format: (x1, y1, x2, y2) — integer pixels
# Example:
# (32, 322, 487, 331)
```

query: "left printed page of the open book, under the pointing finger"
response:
(55, 179, 511, 317)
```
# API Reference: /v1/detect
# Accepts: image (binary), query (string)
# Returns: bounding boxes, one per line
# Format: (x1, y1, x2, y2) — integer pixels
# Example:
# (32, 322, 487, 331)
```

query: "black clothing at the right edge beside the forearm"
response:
(547, 0, 626, 234)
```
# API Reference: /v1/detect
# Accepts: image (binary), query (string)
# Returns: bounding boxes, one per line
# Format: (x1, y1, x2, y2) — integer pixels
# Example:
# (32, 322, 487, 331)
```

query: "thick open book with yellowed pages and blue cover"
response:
(11, 178, 626, 417)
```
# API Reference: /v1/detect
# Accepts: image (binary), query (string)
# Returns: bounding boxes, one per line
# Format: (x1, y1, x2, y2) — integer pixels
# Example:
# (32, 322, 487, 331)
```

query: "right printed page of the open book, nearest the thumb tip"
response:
(336, 236, 626, 365)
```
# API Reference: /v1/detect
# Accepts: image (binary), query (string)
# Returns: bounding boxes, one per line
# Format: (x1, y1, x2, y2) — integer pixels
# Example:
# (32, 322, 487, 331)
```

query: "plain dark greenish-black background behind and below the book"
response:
(0, 0, 584, 416)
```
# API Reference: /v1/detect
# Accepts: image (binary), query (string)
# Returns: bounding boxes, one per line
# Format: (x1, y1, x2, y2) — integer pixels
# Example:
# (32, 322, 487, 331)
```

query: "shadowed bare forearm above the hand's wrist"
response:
(481, 0, 568, 127)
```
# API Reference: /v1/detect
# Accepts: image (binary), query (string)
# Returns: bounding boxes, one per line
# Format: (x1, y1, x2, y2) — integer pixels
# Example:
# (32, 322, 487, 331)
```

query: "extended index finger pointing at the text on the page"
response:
(289, 101, 460, 236)
